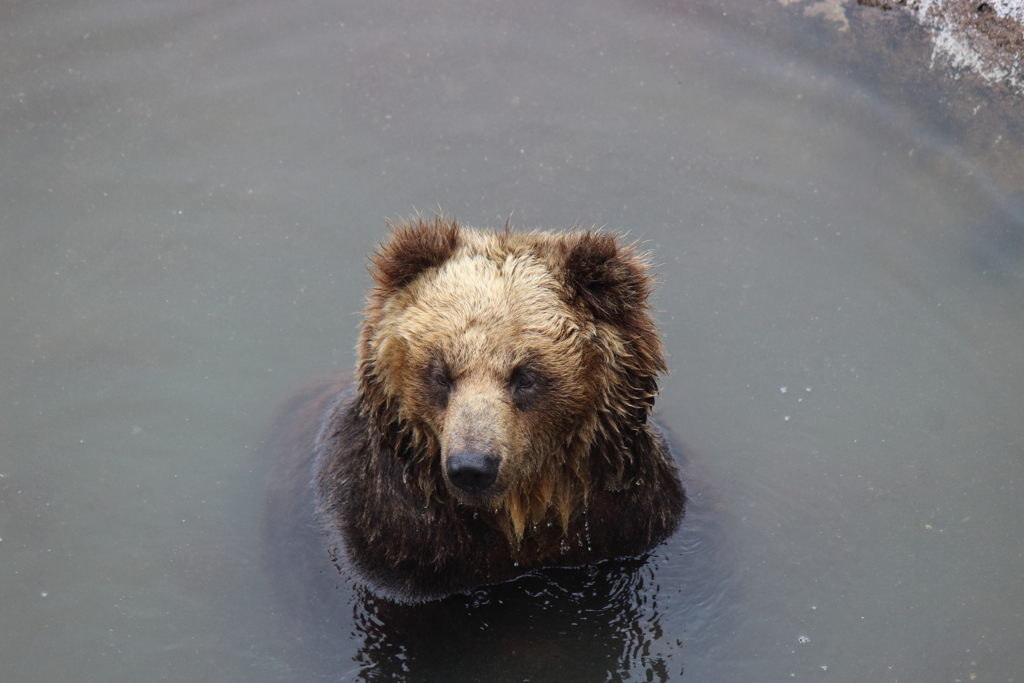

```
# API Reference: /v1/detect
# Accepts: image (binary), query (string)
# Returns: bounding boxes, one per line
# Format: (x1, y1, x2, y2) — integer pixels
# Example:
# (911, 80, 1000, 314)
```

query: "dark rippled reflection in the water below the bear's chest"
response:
(353, 560, 671, 681)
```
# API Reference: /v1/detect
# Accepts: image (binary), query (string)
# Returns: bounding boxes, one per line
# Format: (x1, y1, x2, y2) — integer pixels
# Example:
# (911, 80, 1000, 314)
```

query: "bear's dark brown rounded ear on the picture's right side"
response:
(563, 230, 653, 328)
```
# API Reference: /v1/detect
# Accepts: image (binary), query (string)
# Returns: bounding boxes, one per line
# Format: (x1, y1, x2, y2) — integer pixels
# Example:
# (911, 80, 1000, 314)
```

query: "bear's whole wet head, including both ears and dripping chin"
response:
(358, 217, 666, 544)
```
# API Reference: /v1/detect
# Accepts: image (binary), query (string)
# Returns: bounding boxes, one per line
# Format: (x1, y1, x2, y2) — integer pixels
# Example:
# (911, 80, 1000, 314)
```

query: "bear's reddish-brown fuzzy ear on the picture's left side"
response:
(370, 216, 460, 292)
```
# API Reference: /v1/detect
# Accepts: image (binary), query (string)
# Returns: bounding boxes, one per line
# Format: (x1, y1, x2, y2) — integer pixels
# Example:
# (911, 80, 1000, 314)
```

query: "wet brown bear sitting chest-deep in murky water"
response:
(260, 217, 686, 602)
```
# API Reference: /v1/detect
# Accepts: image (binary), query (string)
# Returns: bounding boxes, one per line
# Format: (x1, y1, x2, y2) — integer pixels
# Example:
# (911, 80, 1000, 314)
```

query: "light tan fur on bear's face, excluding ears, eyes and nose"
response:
(360, 222, 663, 546)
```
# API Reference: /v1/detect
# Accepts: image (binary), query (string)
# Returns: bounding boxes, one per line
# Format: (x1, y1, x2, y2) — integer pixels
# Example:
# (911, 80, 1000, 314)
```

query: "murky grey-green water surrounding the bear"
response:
(0, 0, 1024, 682)
